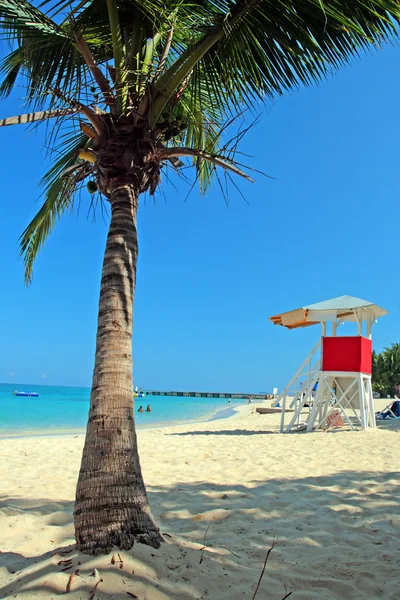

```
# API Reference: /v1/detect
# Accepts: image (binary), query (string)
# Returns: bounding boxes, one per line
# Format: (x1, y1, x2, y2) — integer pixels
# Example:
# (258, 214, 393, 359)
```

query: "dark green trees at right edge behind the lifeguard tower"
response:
(372, 343, 400, 397)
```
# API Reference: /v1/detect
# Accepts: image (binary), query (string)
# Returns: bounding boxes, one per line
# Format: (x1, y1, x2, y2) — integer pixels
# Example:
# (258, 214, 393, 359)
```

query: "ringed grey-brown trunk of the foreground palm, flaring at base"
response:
(74, 185, 162, 554)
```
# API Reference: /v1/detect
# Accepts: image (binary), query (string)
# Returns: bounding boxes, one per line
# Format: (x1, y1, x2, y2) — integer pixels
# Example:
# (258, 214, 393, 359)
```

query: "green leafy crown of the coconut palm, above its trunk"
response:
(0, 0, 399, 280)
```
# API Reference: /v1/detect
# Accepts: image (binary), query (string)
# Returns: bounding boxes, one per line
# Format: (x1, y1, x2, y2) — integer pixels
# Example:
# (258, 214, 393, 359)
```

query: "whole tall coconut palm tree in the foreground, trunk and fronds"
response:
(0, 0, 398, 554)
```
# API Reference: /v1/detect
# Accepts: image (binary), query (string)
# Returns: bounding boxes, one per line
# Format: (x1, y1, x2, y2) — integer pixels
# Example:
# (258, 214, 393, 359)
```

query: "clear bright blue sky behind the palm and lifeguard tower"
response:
(0, 41, 400, 392)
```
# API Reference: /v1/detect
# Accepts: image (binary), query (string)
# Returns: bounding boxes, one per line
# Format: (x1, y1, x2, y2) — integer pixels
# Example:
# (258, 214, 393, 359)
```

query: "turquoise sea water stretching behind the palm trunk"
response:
(0, 383, 247, 436)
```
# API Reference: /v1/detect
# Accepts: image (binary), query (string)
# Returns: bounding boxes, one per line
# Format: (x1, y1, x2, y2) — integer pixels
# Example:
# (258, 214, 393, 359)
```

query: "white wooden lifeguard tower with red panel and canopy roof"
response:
(270, 296, 388, 433)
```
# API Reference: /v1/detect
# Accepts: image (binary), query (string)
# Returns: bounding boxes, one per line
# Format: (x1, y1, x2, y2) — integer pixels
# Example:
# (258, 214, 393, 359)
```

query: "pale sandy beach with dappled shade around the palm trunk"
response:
(0, 401, 400, 600)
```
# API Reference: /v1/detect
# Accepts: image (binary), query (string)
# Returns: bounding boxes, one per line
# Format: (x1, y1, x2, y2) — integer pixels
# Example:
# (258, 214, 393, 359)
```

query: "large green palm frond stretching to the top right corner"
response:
(151, 0, 400, 122)
